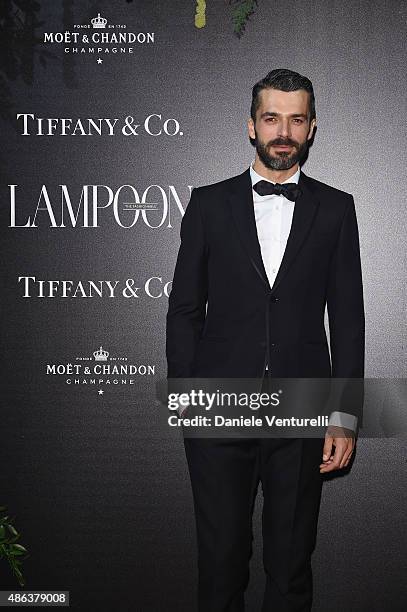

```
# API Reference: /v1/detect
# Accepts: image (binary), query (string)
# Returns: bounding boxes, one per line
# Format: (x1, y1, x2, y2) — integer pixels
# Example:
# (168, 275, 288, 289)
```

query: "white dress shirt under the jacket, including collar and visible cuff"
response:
(250, 162, 357, 431)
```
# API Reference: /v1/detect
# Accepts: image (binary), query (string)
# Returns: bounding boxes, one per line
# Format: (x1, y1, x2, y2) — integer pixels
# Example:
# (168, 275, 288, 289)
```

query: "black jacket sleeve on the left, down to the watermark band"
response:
(166, 188, 208, 378)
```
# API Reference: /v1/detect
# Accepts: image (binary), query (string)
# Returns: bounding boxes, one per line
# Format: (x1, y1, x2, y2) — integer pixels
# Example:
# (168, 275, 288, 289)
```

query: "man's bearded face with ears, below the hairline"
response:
(248, 89, 316, 170)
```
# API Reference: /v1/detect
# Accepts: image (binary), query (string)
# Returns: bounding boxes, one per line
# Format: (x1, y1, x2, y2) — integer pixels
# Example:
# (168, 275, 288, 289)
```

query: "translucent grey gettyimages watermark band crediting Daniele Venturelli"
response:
(156, 377, 407, 438)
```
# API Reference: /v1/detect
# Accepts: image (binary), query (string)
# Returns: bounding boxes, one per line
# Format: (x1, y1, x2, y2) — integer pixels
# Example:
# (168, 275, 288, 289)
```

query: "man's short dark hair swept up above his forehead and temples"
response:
(250, 68, 316, 123)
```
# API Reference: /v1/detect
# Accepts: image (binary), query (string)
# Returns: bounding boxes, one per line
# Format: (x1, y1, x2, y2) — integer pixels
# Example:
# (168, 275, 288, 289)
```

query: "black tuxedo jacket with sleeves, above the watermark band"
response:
(166, 169, 365, 390)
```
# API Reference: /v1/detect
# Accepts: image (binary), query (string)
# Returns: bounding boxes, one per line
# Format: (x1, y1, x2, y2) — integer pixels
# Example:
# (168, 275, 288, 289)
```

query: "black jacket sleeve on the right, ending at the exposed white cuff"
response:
(327, 196, 365, 426)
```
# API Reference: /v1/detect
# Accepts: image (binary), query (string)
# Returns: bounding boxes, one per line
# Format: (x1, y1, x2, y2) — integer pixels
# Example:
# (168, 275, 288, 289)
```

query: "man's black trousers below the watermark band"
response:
(184, 381, 324, 612)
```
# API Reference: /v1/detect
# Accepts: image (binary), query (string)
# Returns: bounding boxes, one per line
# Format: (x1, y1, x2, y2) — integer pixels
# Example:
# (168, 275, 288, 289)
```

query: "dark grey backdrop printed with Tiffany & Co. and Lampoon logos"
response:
(0, 0, 407, 612)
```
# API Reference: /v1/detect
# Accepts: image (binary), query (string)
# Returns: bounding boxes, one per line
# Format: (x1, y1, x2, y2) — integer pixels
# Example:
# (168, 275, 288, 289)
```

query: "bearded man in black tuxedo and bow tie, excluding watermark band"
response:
(167, 69, 364, 612)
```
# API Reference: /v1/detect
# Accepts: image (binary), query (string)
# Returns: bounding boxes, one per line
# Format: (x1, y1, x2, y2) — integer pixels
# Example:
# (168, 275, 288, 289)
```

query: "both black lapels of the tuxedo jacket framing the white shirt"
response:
(228, 168, 319, 292)
